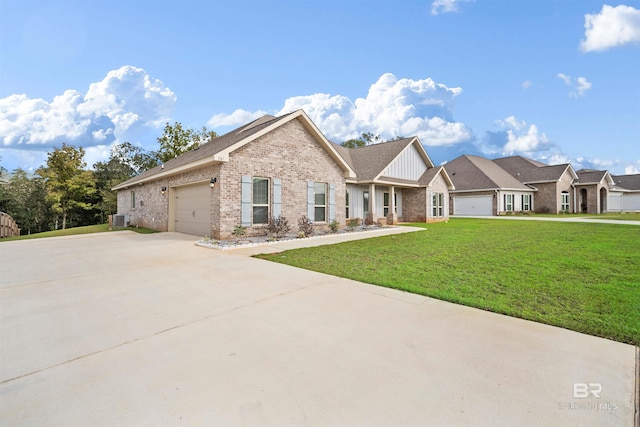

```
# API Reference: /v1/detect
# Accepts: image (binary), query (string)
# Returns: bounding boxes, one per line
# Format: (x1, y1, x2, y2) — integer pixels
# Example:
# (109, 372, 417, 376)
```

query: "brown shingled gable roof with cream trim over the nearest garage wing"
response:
(113, 110, 355, 190)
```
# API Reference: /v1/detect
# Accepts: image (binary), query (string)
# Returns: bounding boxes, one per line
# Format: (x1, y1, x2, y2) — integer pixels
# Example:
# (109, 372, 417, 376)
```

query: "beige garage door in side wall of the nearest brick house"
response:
(174, 183, 211, 236)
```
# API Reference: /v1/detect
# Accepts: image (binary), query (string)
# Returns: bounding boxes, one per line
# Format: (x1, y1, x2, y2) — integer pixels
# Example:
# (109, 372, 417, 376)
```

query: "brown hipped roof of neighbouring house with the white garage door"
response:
(444, 154, 534, 192)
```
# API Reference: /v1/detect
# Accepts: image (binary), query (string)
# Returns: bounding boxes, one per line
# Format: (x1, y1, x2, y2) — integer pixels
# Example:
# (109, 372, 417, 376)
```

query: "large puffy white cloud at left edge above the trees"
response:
(0, 66, 176, 151)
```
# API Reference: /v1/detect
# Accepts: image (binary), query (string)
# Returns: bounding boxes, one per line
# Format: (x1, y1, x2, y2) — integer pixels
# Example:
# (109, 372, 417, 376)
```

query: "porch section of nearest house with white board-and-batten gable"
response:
(336, 137, 454, 224)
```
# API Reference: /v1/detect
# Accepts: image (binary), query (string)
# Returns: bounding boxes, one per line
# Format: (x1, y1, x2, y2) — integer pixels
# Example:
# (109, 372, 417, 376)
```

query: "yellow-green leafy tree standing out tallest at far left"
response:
(37, 144, 96, 230)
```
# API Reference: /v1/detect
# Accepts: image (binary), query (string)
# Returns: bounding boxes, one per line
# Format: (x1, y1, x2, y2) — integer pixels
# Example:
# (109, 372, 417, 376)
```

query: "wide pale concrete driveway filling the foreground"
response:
(0, 232, 638, 426)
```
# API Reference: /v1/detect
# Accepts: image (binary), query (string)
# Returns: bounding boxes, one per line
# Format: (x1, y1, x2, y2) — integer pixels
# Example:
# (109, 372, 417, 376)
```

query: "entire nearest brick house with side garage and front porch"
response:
(113, 110, 453, 239)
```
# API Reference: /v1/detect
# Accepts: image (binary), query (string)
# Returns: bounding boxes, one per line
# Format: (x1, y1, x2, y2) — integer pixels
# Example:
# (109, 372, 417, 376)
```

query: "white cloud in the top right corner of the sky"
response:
(580, 4, 640, 52)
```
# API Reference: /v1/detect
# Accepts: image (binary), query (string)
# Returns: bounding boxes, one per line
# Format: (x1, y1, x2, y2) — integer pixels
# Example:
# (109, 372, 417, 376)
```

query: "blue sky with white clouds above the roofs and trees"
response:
(0, 0, 640, 174)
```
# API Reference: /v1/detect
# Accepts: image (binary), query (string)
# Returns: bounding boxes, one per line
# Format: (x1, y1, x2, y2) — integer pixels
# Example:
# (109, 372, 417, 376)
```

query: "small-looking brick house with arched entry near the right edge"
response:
(574, 169, 615, 214)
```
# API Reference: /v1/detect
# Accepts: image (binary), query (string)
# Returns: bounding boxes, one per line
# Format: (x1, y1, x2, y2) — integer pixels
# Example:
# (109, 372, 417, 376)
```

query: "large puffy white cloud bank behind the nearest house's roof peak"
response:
(208, 73, 472, 145)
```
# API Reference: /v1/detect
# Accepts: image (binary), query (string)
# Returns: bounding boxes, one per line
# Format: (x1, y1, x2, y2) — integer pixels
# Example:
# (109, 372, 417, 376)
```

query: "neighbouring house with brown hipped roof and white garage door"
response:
(444, 155, 536, 216)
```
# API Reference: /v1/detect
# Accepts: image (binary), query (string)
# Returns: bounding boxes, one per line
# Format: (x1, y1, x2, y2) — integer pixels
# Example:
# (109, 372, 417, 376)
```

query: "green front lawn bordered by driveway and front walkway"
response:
(260, 218, 640, 345)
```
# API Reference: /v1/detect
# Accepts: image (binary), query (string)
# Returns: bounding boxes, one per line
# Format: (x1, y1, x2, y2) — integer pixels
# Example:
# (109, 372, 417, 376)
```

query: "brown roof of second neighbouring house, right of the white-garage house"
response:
(493, 156, 578, 184)
